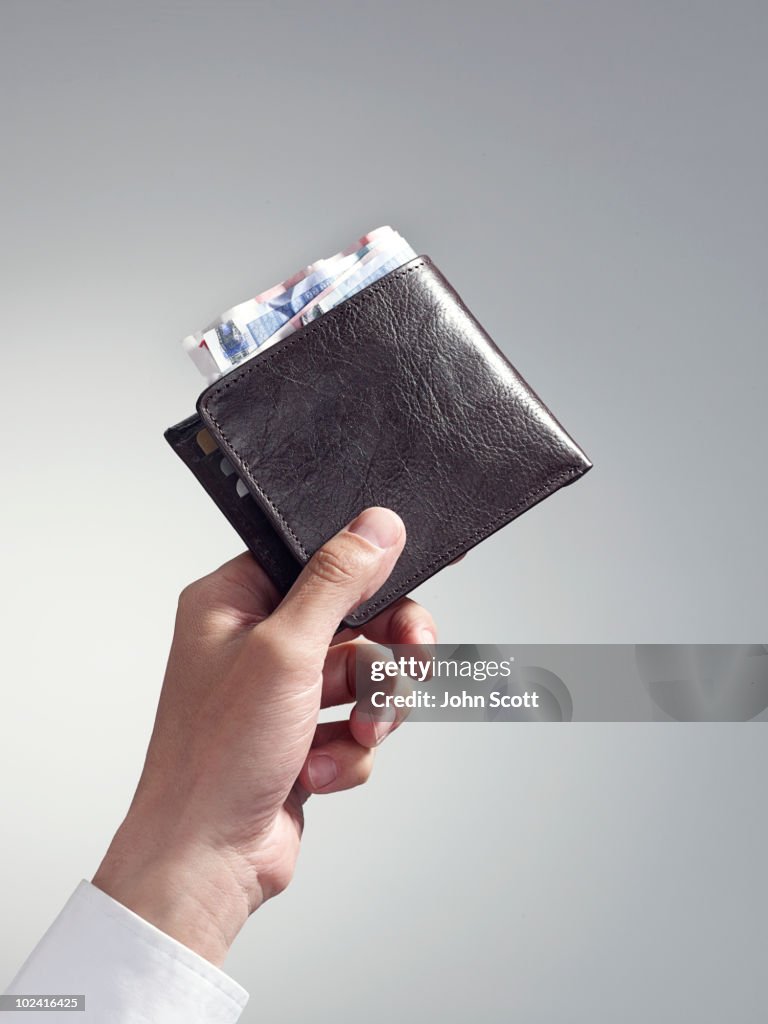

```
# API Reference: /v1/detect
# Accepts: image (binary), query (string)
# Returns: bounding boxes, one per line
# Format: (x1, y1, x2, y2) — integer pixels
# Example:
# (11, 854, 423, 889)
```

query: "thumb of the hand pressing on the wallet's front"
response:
(270, 508, 406, 647)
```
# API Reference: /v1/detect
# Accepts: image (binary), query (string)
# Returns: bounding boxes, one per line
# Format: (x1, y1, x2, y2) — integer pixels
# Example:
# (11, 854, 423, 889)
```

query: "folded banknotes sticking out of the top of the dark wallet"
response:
(183, 225, 416, 382)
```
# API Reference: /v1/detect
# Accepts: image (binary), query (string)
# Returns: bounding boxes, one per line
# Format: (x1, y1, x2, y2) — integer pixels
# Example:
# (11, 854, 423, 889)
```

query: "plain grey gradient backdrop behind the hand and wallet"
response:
(0, 0, 768, 1024)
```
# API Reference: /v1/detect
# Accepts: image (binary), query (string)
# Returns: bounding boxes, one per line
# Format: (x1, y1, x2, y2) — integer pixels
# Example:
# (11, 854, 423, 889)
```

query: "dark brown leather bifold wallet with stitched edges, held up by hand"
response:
(165, 256, 592, 628)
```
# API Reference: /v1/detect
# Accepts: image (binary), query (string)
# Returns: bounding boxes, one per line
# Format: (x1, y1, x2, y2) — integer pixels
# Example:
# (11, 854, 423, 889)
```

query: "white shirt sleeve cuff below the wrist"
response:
(0, 880, 248, 1024)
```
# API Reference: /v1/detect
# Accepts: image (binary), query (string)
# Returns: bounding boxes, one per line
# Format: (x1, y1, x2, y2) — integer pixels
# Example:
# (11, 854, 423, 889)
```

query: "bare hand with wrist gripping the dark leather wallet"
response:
(93, 509, 435, 965)
